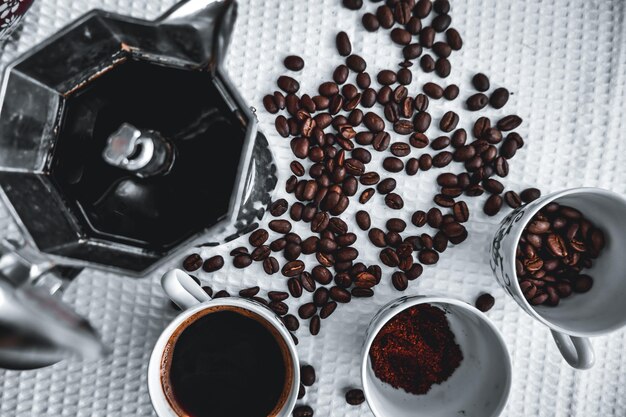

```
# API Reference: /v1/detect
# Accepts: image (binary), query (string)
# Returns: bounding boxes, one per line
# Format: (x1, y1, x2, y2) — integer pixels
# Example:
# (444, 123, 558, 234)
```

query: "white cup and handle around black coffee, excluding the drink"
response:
(148, 269, 300, 417)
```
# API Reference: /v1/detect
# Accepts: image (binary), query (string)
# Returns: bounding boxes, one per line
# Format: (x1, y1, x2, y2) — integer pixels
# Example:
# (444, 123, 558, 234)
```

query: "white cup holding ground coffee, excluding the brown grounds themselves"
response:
(361, 296, 511, 417)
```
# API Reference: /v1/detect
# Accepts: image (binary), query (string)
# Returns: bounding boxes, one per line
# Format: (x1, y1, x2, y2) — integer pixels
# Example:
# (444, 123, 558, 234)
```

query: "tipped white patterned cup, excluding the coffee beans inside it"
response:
(490, 188, 626, 369)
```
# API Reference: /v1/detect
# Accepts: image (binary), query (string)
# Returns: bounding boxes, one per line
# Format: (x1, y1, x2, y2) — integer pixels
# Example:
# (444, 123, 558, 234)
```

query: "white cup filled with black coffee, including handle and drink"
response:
(148, 270, 300, 417)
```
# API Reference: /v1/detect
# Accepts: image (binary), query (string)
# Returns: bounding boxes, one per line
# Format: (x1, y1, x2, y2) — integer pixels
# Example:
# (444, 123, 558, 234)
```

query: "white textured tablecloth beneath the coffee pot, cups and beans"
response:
(0, 0, 626, 417)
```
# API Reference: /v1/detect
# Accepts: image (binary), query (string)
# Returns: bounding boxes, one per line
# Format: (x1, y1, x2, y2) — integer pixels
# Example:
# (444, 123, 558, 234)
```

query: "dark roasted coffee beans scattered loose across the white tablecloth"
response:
(183, 0, 540, 416)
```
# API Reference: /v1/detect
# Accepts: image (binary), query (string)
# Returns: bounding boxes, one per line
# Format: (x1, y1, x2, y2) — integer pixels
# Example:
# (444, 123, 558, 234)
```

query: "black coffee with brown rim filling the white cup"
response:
(161, 306, 293, 417)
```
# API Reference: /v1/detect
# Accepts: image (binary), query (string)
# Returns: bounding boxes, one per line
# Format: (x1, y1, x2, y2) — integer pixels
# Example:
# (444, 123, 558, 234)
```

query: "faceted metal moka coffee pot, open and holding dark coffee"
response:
(0, 0, 277, 369)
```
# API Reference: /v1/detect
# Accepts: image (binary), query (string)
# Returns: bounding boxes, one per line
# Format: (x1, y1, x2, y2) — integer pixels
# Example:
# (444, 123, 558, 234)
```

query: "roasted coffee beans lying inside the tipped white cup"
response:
(515, 202, 605, 307)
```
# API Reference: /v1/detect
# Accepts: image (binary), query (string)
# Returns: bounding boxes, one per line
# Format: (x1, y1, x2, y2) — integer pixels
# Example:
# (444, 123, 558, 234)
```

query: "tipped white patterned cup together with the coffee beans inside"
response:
(490, 188, 626, 369)
